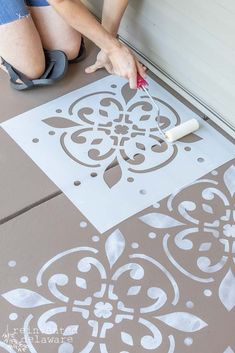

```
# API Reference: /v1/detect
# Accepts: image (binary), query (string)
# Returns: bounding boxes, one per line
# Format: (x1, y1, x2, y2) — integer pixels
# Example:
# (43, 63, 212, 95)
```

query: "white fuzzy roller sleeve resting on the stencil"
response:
(165, 119, 199, 142)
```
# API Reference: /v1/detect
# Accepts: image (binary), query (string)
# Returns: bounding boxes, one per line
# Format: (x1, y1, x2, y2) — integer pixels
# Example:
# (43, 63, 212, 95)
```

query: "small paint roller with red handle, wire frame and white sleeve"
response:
(137, 74, 200, 142)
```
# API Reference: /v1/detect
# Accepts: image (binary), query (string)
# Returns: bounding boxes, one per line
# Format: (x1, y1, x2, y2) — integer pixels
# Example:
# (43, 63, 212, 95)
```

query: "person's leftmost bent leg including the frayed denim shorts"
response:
(0, 0, 45, 79)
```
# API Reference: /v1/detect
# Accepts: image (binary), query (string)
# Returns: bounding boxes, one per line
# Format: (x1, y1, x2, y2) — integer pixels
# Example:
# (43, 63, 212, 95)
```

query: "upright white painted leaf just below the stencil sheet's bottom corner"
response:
(105, 229, 125, 268)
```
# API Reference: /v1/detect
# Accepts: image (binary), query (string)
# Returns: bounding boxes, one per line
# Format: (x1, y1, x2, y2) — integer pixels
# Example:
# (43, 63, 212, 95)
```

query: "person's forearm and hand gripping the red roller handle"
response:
(48, 0, 144, 88)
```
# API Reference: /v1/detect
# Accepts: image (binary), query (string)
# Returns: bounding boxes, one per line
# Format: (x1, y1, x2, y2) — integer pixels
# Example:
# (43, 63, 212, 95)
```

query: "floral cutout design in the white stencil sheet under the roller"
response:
(43, 84, 201, 188)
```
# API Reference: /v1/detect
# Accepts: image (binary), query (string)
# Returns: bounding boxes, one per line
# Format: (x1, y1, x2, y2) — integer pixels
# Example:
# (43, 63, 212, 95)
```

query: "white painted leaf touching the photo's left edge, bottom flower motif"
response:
(2, 288, 52, 308)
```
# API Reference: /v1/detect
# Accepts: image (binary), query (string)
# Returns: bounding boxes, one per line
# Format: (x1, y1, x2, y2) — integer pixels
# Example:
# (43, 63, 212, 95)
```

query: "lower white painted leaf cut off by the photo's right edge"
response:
(219, 268, 235, 311)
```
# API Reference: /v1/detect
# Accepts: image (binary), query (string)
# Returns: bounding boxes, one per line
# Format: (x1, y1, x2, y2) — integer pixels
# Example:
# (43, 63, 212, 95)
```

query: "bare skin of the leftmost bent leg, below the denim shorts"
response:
(0, 16, 45, 79)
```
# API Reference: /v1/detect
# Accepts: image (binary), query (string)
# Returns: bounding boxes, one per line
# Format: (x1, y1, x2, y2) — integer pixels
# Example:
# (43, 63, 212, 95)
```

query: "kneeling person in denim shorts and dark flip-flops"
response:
(0, 0, 145, 89)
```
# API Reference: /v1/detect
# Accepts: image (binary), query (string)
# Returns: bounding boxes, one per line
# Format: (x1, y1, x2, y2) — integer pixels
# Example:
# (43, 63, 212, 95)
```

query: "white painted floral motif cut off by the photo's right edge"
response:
(140, 165, 235, 311)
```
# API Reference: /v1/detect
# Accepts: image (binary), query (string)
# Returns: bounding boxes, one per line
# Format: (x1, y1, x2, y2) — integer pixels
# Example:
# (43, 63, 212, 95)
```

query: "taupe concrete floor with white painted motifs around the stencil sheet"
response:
(0, 41, 235, 353)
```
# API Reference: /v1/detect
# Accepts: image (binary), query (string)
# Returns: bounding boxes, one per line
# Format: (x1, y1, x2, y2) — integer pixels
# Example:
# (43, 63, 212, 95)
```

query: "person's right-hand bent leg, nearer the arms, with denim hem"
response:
(26, 0, 81, 60)
